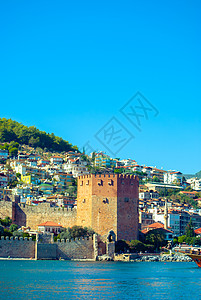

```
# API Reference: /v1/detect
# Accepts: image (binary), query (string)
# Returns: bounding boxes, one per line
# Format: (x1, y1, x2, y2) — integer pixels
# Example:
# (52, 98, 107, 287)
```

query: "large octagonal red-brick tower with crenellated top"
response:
(77, 174, 139, 240)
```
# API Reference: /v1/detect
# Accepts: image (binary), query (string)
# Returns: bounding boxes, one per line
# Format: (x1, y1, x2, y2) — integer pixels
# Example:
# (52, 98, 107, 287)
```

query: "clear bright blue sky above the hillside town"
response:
(0, 0, 201, 174)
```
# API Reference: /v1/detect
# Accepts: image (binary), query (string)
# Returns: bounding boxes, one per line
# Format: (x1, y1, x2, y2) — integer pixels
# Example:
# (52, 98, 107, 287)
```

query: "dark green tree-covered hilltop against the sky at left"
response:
(0, 118, 78, 152)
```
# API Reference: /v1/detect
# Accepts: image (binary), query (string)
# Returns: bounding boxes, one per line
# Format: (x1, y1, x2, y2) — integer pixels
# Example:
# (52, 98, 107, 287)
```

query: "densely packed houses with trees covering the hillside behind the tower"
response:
(0, 144, 201, 247)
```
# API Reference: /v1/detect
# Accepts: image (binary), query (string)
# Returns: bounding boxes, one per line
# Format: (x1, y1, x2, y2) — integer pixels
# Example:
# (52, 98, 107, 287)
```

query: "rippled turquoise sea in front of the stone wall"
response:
(0, 260, 201, 300)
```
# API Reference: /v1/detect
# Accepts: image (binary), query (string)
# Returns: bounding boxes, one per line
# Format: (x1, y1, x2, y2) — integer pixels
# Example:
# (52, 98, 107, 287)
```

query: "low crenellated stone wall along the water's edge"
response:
(0, 234, 100, 260)
